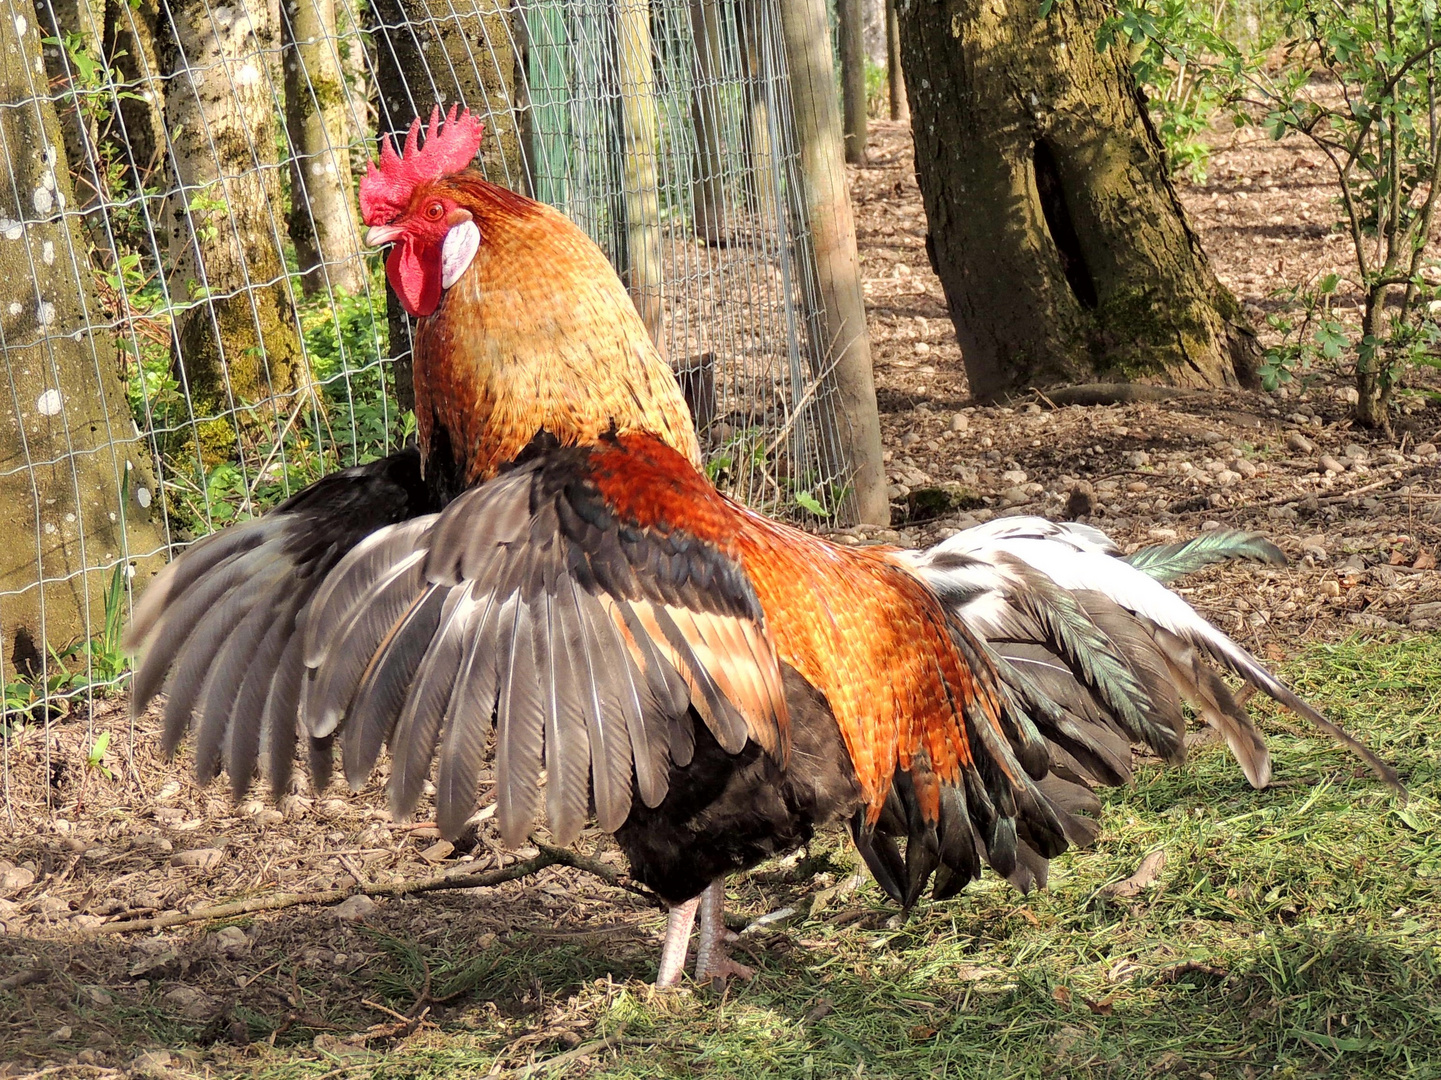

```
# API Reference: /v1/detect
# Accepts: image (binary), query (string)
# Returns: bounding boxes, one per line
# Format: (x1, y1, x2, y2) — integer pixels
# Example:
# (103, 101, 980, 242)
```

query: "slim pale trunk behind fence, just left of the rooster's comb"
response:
(281, 0, 366, 296)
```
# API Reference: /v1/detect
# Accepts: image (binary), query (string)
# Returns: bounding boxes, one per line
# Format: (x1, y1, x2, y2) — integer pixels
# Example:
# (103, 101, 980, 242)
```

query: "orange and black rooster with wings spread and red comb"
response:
(128, 108, 1395, 985)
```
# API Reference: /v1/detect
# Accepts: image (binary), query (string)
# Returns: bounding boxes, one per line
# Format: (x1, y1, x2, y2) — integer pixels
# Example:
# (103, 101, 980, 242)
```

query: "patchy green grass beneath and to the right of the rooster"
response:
(14, 636, 1441, 1080)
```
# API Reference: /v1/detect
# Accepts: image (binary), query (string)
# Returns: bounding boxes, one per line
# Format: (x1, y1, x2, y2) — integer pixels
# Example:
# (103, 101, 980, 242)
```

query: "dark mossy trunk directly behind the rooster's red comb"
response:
(369, 0, 526, 408)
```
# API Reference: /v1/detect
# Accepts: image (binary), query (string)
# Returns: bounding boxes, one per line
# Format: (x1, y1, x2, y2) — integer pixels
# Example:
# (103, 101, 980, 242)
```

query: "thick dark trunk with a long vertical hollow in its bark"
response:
(898, 0, 1259, 398)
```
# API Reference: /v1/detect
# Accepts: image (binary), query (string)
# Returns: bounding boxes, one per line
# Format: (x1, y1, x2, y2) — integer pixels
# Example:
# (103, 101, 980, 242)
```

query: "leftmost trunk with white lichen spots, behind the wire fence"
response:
(0, 1, 163, 682)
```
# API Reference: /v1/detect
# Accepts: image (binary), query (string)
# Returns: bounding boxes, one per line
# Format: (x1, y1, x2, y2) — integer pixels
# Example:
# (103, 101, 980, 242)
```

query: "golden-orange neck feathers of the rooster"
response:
(415, 173, 700, 483)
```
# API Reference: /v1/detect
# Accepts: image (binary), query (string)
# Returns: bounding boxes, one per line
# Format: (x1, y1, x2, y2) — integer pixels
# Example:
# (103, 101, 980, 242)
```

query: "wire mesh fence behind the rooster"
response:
(0, 0, 846, 777)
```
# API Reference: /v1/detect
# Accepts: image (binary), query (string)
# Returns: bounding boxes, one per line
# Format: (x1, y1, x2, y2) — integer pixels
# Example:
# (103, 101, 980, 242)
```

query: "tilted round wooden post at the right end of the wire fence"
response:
(778, 0, 891, 525)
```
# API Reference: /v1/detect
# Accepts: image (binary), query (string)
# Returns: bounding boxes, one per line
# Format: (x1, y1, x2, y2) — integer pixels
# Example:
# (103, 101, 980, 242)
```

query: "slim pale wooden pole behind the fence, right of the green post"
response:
(615, 0, 664, 342)
